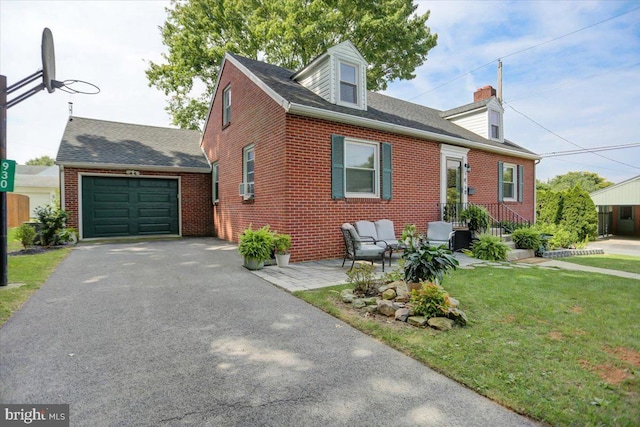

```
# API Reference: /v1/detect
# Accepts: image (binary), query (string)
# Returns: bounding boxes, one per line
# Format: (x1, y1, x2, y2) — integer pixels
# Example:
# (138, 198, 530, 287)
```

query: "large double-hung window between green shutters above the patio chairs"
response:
(344, 140, 380, 197)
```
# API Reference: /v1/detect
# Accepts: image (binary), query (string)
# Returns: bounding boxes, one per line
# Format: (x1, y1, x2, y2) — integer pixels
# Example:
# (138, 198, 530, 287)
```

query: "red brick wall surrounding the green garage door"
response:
(64, 167, 212, 236)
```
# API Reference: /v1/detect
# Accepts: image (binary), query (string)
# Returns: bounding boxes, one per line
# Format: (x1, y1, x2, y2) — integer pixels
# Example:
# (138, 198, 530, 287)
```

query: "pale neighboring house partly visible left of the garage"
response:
(13, 165, 60, 218)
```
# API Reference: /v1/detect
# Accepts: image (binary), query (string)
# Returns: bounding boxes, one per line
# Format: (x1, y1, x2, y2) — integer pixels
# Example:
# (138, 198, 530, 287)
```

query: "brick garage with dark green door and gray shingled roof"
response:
(56, 117, 212, 239)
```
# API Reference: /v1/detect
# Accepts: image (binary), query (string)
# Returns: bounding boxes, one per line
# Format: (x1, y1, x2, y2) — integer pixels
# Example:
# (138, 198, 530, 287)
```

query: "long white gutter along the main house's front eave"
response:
(283, 103, 541, 160)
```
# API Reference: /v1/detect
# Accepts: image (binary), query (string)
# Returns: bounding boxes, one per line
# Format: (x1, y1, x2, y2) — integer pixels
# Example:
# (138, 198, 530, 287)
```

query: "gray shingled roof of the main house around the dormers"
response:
(230, 54, 534, 154)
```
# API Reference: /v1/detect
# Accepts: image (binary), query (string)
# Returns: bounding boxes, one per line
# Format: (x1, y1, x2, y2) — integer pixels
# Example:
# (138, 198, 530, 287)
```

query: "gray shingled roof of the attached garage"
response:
(56, 117, 209, 172)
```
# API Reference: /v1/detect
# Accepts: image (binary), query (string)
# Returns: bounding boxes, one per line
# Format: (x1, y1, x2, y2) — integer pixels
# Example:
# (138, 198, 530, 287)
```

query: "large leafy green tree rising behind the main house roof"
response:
(146, 0, 437, 129)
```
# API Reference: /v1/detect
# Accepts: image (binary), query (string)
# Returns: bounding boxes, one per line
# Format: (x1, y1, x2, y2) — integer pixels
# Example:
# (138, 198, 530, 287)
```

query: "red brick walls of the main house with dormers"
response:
(203, 62, 535, 261)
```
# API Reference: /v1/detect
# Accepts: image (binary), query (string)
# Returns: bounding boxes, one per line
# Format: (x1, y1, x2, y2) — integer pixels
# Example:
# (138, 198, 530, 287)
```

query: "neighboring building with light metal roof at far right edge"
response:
(589, 175, 640, 237)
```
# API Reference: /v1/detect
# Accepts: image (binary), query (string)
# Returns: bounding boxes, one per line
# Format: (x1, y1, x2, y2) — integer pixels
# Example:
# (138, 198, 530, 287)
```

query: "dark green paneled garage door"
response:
(82, 176, 179, 238)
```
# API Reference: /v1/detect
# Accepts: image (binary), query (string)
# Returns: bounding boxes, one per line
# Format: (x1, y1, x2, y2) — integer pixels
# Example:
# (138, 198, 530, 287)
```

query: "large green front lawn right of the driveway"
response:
(296, 267, 640, 426)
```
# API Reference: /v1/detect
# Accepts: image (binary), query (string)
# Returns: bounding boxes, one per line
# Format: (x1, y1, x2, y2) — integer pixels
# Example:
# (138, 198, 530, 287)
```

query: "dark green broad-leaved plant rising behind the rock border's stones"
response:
(402, 243, 458, 283)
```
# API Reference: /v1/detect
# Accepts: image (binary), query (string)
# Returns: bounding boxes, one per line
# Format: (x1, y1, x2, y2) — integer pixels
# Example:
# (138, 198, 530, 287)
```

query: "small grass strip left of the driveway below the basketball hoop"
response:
(0, 248, 71, 326)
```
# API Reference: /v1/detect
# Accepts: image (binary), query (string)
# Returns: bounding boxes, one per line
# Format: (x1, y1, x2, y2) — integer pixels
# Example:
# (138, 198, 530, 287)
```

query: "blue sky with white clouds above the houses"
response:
(0, 0, 640, 182)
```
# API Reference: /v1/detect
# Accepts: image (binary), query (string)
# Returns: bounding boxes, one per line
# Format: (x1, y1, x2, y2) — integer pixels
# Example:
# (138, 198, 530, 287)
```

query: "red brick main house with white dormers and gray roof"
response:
(202, 42, 539, 261)
